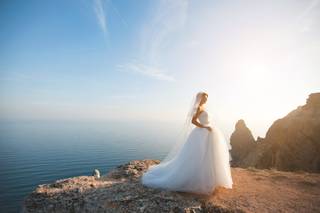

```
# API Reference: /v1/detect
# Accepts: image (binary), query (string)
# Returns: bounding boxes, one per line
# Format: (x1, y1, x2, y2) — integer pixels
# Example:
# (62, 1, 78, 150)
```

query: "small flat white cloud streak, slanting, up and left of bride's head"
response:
(118, 62, 175, 81)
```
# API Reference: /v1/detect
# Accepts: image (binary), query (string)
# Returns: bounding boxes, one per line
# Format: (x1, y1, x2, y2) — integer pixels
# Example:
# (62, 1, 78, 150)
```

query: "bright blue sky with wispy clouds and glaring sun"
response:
(0, 0, 320, 137)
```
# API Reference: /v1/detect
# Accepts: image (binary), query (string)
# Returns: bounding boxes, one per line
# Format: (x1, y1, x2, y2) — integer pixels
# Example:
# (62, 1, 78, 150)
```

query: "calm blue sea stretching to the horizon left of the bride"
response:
(0, 121, 179, 212)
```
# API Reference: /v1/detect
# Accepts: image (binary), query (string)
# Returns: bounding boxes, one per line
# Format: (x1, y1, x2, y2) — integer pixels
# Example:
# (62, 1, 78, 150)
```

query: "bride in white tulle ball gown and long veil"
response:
(141, 92, 233, 194)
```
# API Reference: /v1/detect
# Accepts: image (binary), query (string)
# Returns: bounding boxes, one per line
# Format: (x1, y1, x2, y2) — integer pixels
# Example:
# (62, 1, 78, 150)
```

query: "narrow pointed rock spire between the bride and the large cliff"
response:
(230, 120, 256, 166)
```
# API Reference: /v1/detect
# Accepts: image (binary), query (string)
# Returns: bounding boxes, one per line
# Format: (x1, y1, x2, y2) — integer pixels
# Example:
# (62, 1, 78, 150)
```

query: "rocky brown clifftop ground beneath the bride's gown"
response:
(22, 160, 320, 213)
